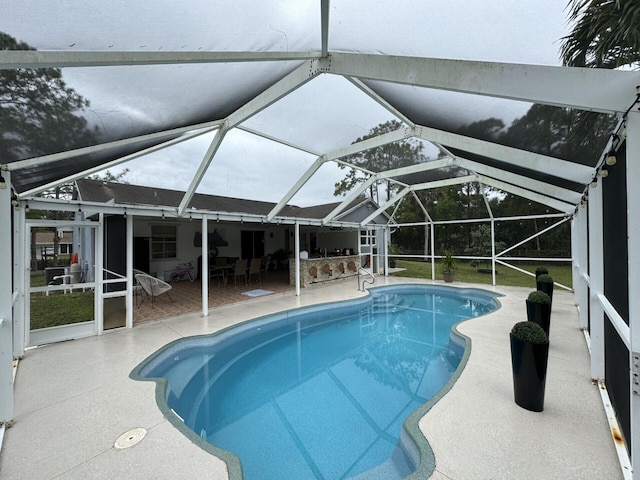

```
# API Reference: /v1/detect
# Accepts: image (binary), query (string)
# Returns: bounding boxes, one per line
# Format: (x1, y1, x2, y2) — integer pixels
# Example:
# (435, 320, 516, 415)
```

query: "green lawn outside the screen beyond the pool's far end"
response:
(393, 259, 572, 290)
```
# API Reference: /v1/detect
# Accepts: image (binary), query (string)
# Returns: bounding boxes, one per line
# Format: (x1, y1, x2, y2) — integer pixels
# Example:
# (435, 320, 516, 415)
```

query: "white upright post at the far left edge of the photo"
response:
(0, 170, 14, 423)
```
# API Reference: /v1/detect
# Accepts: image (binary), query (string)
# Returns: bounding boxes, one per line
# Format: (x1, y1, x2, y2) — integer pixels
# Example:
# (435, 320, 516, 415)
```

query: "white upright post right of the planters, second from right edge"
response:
(587, 182, 604, 380)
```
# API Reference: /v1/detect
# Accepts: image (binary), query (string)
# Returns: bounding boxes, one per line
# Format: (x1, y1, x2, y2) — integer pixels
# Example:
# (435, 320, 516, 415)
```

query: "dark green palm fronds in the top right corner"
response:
(560, 0, 640, 68)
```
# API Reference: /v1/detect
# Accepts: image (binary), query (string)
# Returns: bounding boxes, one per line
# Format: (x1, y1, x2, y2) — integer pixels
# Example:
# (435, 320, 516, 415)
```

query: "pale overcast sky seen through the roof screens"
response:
(0, 0, 568, 206)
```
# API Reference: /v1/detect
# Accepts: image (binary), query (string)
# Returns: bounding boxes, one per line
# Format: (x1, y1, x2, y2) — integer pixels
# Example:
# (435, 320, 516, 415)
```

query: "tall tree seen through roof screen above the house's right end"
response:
(333, 120, 425, 200)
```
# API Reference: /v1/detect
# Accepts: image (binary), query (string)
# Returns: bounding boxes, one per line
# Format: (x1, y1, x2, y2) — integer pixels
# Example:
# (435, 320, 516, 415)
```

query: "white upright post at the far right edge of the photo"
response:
(626, 109, 640, 480)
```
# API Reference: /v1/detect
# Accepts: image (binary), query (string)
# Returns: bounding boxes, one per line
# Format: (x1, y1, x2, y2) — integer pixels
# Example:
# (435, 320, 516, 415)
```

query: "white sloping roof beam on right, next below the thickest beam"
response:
(416, 127, 594, 183)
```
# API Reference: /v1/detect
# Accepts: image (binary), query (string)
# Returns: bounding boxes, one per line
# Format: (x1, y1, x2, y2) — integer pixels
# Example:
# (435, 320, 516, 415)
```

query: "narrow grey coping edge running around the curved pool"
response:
(129, 283, 503, 480)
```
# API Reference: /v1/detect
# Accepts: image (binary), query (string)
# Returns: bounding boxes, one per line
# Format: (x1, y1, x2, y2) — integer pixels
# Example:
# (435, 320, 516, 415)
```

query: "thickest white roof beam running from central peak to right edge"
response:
(326, 52, 638, 113)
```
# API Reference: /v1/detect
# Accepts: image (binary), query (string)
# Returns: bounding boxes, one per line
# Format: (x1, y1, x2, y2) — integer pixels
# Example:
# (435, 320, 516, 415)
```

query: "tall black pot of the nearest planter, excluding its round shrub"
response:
(510, 334, 549, 412)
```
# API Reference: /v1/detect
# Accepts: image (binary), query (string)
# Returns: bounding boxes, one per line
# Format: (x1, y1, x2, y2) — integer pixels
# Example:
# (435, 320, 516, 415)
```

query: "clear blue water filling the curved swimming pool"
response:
(132, 285, 498, 480)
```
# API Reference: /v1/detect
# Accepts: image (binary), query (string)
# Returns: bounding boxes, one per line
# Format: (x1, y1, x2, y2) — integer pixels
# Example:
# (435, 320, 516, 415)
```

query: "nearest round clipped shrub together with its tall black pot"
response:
(509, 321, 549, 412)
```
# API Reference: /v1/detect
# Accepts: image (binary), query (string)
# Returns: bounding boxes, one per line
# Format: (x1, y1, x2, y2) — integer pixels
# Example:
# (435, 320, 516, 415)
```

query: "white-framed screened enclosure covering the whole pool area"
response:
(0, 0, 640, 479)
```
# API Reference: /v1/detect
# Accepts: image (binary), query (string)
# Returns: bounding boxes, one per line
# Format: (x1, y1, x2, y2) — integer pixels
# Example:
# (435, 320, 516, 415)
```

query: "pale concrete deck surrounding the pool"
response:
(0, 277, 623, 480)
